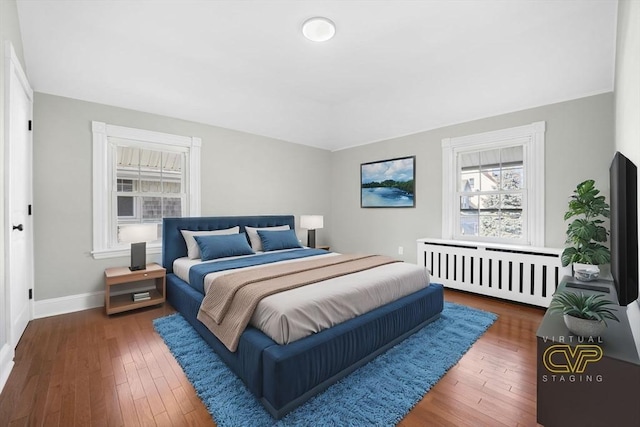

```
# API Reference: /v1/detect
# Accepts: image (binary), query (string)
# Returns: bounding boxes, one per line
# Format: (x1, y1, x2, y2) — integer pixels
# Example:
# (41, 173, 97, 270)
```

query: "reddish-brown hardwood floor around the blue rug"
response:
(0, 290, 544, 427)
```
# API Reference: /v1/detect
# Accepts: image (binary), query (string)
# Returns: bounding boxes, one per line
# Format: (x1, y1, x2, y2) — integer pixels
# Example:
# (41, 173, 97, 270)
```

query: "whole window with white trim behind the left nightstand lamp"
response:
(92, 122, 201, 258)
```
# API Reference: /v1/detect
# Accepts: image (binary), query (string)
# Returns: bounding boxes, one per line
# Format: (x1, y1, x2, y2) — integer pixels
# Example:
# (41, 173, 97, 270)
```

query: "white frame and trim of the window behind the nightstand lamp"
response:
(91, 121, 202, 259)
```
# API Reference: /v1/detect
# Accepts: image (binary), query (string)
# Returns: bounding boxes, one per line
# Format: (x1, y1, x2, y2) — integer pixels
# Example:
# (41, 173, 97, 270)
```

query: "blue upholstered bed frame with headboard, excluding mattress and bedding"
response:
(162, 215, 443, 419)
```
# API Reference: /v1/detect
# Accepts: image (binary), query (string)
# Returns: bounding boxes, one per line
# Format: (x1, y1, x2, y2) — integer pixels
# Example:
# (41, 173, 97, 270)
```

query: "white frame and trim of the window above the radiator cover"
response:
(442, 121, 546, 247)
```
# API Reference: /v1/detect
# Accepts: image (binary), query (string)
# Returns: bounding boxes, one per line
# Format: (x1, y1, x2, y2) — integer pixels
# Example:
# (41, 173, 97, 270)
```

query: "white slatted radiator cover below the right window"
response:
(417, 238, 571, 308)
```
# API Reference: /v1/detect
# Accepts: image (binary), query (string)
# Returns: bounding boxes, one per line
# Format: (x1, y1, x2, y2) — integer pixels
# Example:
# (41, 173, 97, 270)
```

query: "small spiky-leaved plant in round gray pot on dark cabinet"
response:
(549, 291, 620, 337)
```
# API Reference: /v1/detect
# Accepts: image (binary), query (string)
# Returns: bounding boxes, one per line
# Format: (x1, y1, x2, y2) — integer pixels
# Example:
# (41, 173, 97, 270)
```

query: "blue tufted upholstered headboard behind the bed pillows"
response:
(162, 215, 295, 274)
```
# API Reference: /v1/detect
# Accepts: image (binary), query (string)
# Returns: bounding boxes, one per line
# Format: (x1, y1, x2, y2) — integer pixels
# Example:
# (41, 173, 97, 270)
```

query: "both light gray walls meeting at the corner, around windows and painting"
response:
(34, 93, 614, 301)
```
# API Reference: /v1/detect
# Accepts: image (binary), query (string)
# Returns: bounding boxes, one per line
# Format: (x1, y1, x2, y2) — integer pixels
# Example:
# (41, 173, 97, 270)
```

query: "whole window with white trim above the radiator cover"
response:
(442, 122, 545, 246)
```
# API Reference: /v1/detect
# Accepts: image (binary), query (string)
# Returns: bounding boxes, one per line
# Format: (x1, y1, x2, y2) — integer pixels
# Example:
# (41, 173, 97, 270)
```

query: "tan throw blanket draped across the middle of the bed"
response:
(198, 255, 398, 351)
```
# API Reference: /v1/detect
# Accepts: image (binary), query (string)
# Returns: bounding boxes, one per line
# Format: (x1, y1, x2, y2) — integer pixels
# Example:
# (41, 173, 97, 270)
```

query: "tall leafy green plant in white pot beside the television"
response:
(561, 179, 611, 281)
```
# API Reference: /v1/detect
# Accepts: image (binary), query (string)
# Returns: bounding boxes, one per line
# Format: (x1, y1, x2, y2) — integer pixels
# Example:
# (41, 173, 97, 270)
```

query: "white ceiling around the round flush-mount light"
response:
(18, 0, 617, 150)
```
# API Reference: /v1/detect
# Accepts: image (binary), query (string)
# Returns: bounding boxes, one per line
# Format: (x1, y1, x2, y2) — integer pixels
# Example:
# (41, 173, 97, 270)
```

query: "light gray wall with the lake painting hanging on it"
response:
(330, 93, 614, 262)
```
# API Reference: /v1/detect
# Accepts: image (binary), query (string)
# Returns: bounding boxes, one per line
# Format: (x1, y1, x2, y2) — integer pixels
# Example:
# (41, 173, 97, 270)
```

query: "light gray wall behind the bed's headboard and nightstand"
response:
(33, 93, 331, 301)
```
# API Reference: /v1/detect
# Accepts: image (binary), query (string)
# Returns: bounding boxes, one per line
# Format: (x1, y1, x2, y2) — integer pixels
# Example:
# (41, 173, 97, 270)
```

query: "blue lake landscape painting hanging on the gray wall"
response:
(360, 156, 416, 208)
